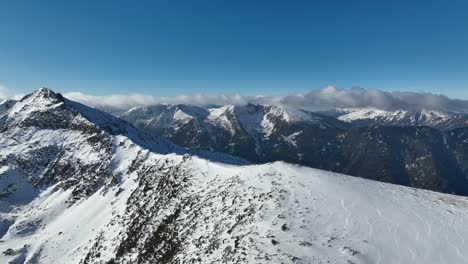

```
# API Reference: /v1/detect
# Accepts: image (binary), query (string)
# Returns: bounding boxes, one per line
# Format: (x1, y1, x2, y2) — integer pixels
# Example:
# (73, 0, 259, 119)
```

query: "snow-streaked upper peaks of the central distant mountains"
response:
(122, 104, 326, 141)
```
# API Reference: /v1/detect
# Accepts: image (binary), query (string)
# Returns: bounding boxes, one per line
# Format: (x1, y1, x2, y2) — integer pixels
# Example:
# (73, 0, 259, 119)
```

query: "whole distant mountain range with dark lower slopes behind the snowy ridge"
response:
(120, 104, 468, 195)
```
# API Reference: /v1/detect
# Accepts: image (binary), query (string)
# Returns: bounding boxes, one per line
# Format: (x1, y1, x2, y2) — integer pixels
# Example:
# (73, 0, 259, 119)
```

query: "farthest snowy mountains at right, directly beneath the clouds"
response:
(328, 108, 468, 130)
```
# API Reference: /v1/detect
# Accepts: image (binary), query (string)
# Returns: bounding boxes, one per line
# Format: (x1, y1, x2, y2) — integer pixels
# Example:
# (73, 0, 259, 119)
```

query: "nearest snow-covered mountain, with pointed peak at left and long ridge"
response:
(0, 89, 468, 263)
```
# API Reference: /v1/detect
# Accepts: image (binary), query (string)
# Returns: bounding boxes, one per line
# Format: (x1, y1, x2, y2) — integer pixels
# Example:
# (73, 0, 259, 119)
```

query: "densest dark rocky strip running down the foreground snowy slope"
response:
(116, 160, 186, 263)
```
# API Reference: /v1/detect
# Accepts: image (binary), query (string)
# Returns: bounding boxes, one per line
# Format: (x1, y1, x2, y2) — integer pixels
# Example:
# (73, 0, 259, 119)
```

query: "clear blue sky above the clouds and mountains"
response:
(0, 0, 468, 98)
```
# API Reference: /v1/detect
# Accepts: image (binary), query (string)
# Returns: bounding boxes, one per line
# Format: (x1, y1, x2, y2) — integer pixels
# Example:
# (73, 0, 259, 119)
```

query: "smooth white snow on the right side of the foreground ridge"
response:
(177, 160, 468, 263)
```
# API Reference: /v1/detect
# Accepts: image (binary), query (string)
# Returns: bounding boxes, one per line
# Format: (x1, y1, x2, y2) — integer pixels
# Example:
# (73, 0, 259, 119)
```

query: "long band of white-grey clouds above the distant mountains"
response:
(64, 86, 468, 112)
